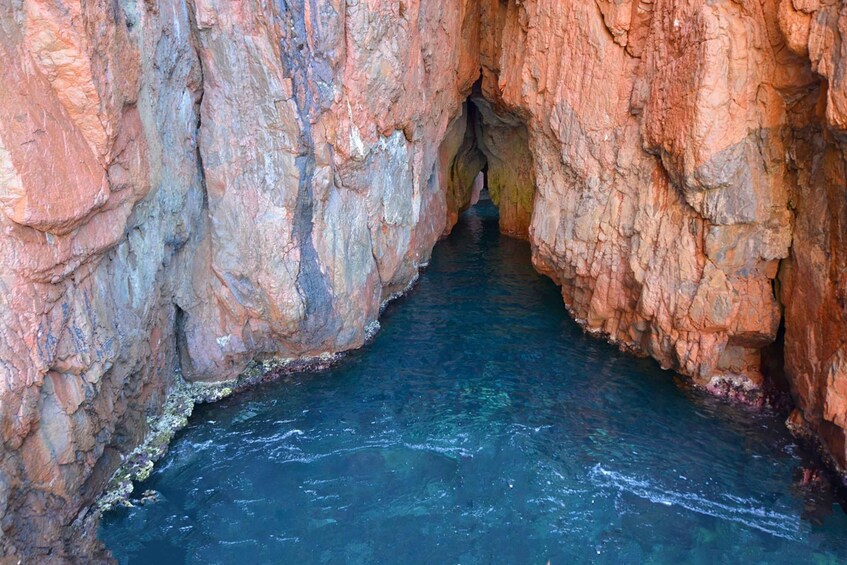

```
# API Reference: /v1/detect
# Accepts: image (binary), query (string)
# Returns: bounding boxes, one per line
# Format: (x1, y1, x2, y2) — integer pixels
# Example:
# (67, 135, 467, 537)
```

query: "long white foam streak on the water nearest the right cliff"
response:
(588, 463, 803, 541)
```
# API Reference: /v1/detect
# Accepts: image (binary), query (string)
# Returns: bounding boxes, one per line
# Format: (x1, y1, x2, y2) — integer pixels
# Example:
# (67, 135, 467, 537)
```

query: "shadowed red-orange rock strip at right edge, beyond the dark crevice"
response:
(779, 0, 847, 476)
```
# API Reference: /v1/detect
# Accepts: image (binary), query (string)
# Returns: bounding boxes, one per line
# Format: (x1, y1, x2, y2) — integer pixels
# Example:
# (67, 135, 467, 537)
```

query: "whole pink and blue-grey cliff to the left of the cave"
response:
(0, 0, 478, 559)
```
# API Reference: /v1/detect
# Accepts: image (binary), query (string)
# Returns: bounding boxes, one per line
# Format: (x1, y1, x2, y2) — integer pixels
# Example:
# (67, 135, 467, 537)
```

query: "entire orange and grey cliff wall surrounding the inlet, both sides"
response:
(0, 0, 847, 559)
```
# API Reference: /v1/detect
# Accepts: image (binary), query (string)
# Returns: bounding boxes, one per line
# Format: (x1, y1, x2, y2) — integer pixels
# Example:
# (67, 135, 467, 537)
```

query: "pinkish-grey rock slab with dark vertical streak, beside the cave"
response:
(177, 1, 490, 380)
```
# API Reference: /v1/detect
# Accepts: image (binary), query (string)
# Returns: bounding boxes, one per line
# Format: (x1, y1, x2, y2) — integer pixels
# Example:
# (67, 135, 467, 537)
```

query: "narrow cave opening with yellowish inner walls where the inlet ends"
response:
(440, 80, 535, 239)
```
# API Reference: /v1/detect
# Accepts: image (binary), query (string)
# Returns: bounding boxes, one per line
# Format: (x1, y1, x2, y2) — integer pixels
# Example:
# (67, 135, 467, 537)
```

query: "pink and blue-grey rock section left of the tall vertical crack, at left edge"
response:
(0, 1, 204, 560)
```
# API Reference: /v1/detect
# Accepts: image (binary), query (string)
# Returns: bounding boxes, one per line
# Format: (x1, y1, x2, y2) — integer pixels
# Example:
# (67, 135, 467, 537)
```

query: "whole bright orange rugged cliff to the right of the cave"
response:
(480, 0, 847, 467)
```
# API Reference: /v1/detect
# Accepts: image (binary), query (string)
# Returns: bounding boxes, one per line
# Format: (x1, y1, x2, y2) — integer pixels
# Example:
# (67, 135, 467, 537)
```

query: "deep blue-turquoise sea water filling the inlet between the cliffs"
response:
(101, 197, 847, 565)
